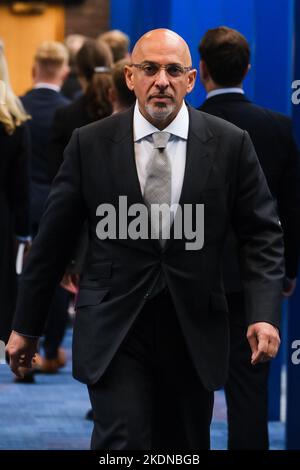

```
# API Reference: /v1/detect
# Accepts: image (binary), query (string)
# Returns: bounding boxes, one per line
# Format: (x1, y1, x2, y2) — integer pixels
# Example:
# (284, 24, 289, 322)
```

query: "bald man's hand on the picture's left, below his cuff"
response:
(6, 331, 39, 378)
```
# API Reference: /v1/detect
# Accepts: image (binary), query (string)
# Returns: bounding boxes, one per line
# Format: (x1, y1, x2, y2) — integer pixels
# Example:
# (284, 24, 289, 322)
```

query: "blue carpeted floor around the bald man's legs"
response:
(0, 330, 284, 450)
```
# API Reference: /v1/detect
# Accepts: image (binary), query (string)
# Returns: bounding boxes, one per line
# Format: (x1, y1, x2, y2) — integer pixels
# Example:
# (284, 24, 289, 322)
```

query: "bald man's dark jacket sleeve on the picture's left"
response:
(13, 130, 86, 336)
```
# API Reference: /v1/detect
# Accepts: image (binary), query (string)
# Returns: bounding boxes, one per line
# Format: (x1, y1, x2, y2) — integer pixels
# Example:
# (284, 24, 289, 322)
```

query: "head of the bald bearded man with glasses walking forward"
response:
(125, 29, 197, 130)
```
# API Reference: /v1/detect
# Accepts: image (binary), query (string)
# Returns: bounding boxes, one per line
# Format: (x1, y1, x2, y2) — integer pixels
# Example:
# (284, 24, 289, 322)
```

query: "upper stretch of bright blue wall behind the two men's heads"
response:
(111, 0, 294, 114)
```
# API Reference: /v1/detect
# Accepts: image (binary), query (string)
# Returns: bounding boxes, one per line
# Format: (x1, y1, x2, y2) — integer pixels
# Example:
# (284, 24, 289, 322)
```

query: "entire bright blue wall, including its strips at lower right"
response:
(111, 0, 300, 449)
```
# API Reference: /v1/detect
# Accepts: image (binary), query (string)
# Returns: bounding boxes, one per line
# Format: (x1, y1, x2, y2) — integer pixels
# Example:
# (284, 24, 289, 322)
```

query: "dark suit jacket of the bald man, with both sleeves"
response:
(14, 104, 283, 390)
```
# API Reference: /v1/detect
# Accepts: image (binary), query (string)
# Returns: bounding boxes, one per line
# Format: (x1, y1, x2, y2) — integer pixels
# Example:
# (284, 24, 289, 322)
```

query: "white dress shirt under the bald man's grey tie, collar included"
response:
(133, 102, 189, 204)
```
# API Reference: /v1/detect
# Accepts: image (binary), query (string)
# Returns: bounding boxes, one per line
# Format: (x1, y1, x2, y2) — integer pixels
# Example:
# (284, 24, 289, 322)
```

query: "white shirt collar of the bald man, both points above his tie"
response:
(133, 101, 189, 142)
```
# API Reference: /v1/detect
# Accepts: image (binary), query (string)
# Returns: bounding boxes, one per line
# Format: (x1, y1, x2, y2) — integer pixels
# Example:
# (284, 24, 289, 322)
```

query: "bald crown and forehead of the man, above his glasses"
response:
(132, 28, 192, 67)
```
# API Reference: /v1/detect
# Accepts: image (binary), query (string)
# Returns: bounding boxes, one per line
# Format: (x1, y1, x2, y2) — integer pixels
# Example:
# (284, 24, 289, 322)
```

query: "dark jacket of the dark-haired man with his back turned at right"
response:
(199, 93, 300, 292)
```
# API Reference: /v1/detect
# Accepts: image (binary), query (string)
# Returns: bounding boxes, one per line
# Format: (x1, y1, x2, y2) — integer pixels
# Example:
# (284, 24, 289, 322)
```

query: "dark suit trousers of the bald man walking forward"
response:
(88, 290, 213, 450)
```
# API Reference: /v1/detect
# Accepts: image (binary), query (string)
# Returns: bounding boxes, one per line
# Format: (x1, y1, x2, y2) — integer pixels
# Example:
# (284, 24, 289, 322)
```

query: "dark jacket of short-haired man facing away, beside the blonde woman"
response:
(21, 88, 69, 227)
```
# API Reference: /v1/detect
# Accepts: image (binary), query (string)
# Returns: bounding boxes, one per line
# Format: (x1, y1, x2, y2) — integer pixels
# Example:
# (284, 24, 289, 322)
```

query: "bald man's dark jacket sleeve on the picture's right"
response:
(232, 131, 284, 327)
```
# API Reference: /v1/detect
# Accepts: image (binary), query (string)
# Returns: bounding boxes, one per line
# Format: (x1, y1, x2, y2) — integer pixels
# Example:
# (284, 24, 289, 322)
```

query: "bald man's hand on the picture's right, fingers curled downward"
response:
(247, 322, 280, 365)
